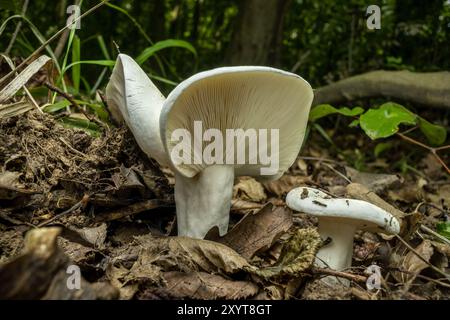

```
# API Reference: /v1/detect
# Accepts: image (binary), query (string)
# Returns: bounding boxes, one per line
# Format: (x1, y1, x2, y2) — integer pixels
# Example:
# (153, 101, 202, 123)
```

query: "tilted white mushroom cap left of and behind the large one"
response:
(106, 54, 169, 165)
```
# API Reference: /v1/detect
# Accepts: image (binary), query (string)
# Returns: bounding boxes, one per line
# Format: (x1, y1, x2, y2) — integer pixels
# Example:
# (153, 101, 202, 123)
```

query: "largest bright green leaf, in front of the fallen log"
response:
(359, 102, 417, 140)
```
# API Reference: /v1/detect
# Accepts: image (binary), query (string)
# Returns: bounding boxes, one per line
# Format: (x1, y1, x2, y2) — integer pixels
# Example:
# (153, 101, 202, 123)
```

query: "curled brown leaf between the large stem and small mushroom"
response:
(214, 204, 293, 259)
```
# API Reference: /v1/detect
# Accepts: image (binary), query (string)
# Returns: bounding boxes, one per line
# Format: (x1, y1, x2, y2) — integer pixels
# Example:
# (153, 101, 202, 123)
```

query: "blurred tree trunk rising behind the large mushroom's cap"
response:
(225, 0, 290, 65)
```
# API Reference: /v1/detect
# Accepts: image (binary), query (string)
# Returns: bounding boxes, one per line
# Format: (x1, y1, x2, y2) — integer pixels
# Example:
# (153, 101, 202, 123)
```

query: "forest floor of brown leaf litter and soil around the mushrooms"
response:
(0, 105, 450, 300)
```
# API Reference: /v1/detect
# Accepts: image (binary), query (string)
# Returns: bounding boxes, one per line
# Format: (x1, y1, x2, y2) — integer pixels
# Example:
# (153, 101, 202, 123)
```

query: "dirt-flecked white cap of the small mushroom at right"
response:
(286, 187, 400, 234)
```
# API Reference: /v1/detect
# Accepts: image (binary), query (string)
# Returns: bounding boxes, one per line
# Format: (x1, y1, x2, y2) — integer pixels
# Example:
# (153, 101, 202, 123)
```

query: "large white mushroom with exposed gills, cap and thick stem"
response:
(160, 67, 313, 238)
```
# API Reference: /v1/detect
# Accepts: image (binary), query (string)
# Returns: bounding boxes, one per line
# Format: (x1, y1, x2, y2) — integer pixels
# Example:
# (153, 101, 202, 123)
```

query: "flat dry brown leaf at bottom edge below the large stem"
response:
(152, 272, 259, 300)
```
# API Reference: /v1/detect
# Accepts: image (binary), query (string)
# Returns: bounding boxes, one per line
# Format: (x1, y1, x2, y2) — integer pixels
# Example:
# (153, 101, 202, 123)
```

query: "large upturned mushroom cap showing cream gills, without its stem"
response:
(160, 66, 313, 180)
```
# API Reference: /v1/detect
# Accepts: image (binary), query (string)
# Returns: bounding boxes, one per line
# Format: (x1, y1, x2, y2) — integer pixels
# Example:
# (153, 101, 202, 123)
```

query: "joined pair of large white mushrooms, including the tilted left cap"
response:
(106, 54, 313, 238)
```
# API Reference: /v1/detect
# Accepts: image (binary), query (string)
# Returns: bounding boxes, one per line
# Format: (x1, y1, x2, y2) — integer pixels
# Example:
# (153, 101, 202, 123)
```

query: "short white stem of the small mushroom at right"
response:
(316, 218, 356, 284)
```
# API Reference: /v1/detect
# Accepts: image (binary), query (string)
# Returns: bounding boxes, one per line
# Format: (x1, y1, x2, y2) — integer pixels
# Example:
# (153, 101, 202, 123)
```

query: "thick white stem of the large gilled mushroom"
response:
(175, 165, 234, 239)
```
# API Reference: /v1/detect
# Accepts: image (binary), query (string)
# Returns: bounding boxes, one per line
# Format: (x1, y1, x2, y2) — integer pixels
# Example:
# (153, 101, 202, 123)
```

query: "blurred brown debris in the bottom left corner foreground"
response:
(0, 227, 117, 299)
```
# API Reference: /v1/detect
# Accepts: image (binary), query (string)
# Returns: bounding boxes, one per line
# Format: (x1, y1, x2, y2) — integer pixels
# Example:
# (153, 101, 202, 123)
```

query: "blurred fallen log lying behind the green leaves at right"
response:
(313, 70, 450, 109)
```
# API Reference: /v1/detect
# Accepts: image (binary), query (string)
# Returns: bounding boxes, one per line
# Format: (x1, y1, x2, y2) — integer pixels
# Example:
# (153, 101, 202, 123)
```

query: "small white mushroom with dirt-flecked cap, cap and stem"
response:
(286, 187, 400, 283)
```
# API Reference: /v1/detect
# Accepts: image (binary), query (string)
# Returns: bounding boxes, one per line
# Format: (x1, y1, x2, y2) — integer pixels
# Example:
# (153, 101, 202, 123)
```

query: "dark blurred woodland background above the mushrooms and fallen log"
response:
(0, 0, 450, 90)
